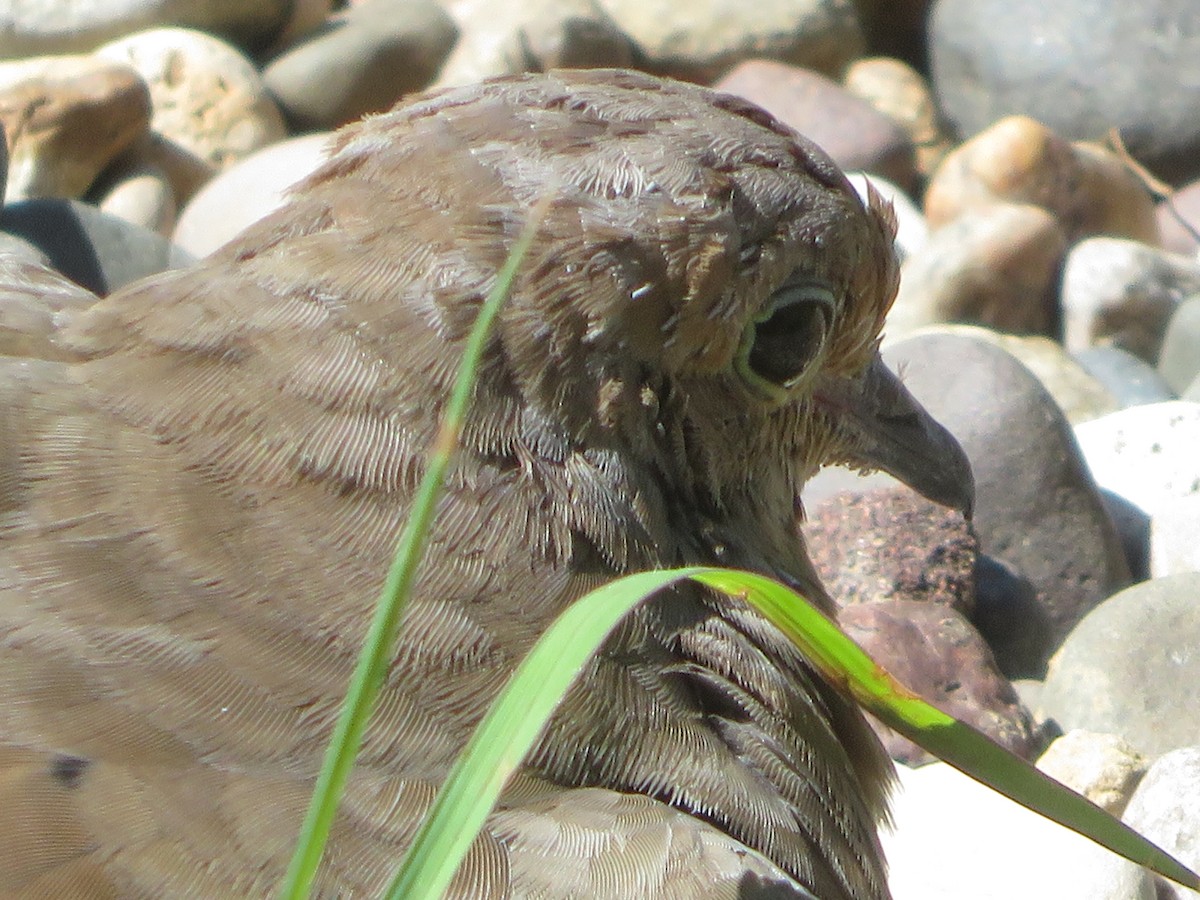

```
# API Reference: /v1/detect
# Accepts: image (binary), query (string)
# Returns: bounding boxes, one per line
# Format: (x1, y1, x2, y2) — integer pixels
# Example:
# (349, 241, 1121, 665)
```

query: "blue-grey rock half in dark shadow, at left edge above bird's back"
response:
(0, 199, 191, 296)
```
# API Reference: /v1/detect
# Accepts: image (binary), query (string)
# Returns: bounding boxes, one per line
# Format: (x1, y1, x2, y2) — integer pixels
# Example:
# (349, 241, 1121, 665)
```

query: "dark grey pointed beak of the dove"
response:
(816, 353, 974, 518)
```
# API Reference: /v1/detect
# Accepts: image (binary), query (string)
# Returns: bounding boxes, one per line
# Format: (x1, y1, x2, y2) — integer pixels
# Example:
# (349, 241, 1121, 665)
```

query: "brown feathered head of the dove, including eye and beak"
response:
(267, 71, 971, 571)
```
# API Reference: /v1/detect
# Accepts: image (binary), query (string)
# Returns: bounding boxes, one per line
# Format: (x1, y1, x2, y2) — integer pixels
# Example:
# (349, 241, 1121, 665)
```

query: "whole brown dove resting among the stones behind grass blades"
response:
(0, 70, 971, 900)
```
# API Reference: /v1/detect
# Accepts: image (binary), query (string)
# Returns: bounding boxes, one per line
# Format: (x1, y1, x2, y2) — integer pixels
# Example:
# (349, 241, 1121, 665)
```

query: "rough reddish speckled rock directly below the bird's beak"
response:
(804, 490, 978, 614)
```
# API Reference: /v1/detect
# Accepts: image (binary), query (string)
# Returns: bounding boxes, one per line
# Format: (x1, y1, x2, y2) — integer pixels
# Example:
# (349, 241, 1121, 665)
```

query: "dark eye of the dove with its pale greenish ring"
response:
(738, 283, 834, 394)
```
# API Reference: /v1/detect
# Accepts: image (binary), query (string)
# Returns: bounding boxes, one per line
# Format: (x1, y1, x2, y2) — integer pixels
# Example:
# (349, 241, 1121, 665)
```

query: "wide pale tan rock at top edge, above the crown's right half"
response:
(600, 0, 863, 84)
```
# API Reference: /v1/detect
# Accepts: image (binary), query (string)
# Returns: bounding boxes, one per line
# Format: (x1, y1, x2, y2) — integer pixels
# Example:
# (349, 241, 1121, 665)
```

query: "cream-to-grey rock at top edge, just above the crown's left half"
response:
(436, 0, 637, 86)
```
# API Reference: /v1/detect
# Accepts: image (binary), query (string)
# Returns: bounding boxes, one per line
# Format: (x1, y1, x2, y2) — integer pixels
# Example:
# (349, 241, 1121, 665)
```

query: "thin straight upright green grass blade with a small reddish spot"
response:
(280, 204, 548, 900)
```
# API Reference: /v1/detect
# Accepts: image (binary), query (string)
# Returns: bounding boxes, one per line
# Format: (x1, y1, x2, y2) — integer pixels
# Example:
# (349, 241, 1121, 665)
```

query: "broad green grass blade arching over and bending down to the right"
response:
(388, 568, 1200, 900)
